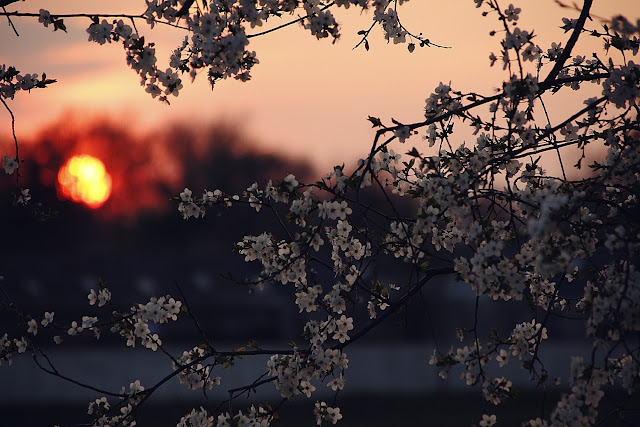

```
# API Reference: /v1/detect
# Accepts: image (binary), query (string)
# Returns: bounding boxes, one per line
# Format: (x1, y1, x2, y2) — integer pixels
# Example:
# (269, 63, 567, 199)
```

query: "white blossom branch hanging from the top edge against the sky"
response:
(11, 0, 440, 102)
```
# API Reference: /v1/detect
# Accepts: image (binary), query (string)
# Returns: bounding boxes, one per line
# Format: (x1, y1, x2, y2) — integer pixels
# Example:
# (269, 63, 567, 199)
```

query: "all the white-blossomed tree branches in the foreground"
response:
(0, 0, 640, 426)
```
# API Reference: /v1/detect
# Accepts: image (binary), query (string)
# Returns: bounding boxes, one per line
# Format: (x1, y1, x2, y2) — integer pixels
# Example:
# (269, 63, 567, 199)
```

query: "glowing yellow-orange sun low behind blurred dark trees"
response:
(58, 154, 111, 209)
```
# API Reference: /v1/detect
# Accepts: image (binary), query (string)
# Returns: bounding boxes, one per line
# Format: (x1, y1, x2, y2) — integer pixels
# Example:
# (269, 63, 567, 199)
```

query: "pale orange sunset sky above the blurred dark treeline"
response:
(0, 0, 640, 172)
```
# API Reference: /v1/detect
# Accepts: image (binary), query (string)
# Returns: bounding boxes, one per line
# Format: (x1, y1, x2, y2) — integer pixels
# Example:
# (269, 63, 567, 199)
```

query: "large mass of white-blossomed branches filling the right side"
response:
(171, 1, 640, 425)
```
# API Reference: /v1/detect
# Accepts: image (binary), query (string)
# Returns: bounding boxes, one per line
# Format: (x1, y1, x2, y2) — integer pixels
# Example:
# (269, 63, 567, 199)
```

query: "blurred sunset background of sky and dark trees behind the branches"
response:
(0, 0, 640, 426)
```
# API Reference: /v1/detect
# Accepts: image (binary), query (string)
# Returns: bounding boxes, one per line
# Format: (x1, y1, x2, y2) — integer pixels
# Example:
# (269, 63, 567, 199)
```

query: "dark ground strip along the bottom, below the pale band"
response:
(0, 393, 640, 427)
